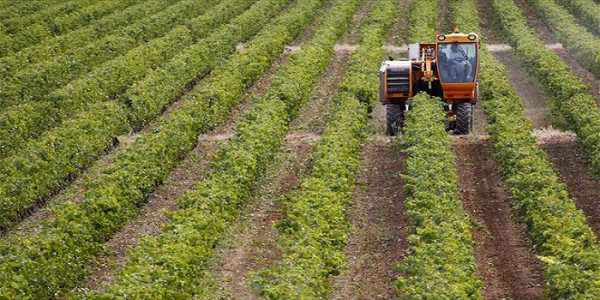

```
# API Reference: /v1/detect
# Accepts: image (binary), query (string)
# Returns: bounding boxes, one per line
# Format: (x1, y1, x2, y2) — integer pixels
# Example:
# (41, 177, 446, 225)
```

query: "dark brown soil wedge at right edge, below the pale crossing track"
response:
(542, 139, 600, 238)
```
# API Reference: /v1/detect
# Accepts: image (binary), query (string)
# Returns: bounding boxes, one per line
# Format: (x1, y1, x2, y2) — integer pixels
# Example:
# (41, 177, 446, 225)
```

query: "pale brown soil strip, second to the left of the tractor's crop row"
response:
(213, 48, 350, 299)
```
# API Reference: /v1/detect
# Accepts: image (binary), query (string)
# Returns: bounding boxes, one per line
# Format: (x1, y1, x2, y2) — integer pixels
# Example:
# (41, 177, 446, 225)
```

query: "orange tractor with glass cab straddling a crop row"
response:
(379, 30, 480, 135)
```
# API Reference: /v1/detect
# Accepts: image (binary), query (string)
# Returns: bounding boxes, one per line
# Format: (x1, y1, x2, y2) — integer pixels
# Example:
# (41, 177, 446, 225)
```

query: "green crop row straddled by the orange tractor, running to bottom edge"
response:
(396, 94, 482, 299)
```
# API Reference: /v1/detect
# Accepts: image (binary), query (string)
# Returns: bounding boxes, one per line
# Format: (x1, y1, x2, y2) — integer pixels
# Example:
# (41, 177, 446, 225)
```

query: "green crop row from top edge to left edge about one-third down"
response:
(0, 0, 227, 106)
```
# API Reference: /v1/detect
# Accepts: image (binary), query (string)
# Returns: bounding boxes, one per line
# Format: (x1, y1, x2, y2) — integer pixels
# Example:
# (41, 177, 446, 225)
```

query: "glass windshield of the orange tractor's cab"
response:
(438, 43, 477, 83)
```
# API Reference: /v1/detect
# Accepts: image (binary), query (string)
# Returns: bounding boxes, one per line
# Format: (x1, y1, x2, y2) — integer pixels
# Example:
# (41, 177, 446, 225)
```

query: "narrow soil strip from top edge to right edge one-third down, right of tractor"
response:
(515, 0, 600, 103)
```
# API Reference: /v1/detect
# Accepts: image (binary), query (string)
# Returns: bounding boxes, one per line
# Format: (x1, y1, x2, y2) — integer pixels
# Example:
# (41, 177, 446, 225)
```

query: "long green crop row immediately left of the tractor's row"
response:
(253, 0, 396, 299)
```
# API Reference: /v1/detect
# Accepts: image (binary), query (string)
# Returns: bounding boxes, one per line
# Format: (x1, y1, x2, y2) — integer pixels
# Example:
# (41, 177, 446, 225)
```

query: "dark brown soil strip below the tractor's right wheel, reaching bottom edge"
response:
(453, 138, 545, 299)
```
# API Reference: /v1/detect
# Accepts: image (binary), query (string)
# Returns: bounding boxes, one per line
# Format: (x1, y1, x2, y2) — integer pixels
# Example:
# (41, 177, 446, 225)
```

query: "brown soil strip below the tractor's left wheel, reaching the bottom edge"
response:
(332, 139, 406, 299)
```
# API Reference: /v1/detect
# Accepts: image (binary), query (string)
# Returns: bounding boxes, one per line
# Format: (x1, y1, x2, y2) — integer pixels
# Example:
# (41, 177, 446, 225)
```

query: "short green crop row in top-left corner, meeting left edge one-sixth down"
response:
(0, 0, 141, 56)
